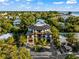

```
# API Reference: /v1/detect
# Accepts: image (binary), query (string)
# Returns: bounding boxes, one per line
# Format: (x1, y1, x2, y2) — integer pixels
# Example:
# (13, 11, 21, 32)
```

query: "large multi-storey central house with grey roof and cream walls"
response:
(26, 19, 51, 45)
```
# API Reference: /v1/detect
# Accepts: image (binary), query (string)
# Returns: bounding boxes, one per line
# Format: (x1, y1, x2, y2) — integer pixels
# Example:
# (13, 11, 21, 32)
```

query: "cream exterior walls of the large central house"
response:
(27, 28, 52, 45)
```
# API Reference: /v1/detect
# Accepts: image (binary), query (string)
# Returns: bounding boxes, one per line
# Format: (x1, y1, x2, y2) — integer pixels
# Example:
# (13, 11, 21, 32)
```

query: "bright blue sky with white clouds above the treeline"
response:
(0, 0, 79, 11)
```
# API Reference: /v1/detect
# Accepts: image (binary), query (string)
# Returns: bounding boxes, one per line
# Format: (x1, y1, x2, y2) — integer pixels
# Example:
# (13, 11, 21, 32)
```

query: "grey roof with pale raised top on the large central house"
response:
(29, 19, 50, 30)
